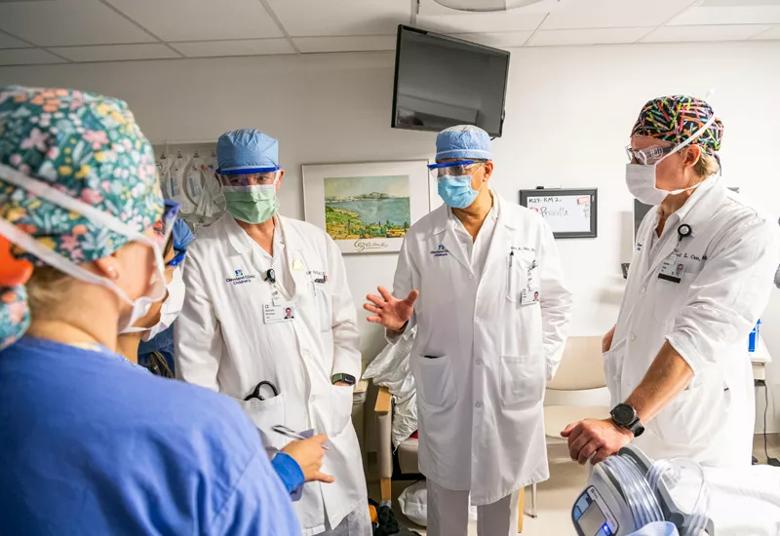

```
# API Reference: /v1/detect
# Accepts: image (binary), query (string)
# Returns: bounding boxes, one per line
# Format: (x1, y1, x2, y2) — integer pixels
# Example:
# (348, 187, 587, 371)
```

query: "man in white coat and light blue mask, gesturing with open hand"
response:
(364, 125, 571, 536)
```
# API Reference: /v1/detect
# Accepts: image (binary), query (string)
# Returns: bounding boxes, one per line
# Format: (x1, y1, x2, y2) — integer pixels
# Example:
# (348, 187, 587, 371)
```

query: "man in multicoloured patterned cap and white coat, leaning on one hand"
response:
(563, 95, 780, 467)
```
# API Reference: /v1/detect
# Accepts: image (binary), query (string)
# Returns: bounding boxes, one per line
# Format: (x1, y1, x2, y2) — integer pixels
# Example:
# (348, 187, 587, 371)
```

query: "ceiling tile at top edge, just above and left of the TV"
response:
(266, 0, 412, 36)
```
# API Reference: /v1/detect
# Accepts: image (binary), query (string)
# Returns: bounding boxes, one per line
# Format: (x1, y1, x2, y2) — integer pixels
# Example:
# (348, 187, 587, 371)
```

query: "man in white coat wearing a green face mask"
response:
(176, 129, 371, 535)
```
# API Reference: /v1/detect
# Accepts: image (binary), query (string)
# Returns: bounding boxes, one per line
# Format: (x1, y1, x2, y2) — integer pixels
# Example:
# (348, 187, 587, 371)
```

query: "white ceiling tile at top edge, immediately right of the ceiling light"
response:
(542, 0, 693, 30)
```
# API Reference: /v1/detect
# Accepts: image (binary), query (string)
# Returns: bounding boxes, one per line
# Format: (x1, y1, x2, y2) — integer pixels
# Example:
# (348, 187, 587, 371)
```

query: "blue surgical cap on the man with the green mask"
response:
(217, 128, 279, 175)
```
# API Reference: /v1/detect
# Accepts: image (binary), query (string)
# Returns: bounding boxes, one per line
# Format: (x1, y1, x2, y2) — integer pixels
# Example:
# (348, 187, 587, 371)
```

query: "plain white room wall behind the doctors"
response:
(0, 42, 780, 431)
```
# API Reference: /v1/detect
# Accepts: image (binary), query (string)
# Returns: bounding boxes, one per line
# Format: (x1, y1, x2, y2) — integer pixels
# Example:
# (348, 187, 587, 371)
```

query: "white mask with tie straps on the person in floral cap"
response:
(0, 164, 165, 333)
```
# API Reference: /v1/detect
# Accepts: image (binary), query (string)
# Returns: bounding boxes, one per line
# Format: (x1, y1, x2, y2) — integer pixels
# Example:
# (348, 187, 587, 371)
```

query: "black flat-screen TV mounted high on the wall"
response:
(391, 25, 509, 137)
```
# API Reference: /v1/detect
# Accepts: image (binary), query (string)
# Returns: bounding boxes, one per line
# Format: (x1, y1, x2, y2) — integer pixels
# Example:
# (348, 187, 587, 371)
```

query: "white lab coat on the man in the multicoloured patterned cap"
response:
(604, 177, 780, 466)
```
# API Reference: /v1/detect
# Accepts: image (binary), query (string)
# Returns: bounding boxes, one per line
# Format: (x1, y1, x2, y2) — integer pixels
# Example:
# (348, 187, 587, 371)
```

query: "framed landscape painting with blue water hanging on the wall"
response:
(301, 160, 431, 254)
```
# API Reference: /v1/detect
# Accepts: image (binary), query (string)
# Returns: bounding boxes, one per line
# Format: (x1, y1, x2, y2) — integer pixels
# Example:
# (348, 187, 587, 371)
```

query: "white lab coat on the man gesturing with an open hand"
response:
(393, 194, 571, 505)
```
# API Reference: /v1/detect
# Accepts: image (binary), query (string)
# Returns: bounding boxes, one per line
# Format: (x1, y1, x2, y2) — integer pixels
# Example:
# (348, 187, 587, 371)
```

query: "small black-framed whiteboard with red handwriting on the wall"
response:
(520, 188, 598, 238)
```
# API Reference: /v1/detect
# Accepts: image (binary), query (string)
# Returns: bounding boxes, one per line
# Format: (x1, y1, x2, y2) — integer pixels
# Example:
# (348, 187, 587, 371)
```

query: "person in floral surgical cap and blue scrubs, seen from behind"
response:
(0, 87, 300, 536)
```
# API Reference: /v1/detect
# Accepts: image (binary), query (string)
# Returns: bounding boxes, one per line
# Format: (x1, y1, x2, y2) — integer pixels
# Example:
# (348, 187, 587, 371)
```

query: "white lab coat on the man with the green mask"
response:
(176, 214, 367, 535)
